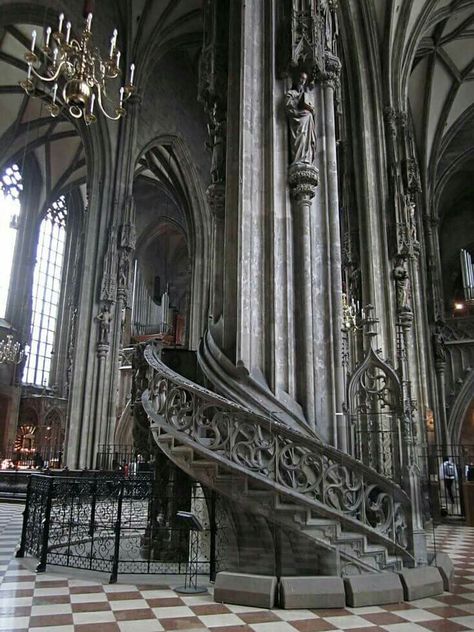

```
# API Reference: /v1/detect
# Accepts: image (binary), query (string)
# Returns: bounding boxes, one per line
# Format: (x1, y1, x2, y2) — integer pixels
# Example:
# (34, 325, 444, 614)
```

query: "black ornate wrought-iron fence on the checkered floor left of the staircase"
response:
(17, 472, 216, 582)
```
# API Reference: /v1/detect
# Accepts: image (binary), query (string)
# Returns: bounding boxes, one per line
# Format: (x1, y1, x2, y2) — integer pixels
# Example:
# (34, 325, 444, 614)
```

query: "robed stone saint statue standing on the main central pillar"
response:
(285, 72, 316, 164)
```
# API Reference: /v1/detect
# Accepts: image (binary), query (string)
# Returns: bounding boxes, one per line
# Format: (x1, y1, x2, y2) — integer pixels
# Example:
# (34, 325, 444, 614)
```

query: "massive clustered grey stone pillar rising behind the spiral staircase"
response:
(196, 0, 346, 448)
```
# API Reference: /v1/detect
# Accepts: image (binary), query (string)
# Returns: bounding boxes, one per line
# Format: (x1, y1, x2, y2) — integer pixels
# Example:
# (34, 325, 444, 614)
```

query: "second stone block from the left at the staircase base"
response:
(280, 576, 346, 608)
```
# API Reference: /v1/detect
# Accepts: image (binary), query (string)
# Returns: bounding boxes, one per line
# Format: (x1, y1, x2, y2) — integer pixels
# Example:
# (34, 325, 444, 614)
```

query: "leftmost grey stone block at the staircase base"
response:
(214, 571, 277, 608)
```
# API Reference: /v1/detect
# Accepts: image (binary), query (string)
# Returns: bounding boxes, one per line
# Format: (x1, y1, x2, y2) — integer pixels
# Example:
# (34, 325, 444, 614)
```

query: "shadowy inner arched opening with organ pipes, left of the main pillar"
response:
(131, 219, 191, 346)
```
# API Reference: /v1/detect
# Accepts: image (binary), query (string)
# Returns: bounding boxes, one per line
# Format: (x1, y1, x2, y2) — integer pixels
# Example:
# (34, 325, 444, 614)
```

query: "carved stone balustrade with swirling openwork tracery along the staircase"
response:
(142, 344, 412, 559)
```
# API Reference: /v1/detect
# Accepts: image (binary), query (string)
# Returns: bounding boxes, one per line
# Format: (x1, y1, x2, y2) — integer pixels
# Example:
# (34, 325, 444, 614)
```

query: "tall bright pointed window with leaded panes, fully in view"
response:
(24, 195, 67, 386)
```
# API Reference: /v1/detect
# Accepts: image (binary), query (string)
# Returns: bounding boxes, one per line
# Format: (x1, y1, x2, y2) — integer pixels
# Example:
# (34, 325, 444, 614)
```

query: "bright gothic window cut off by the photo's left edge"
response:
(0, 165, 23, 318)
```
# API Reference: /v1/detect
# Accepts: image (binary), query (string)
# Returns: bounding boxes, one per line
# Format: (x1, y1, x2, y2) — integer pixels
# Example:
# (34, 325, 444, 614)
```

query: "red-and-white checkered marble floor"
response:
(0, 505, 474, 632)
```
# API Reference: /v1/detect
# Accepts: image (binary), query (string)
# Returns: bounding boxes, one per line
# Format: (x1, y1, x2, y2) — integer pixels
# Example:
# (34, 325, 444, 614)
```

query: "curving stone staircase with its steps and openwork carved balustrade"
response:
(142, 344, 414, 575)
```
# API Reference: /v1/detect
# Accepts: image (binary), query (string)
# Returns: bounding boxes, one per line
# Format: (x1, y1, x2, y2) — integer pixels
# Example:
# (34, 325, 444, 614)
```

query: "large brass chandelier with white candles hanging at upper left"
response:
(20, 13, 135, 125)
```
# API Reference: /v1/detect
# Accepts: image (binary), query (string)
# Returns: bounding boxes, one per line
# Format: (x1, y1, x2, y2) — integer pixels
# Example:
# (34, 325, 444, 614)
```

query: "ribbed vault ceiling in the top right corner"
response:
(382, 0, 474, 192)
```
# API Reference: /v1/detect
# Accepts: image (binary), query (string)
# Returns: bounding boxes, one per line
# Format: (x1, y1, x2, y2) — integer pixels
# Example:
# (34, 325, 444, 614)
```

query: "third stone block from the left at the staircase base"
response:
(344, 573, 403, 608)
